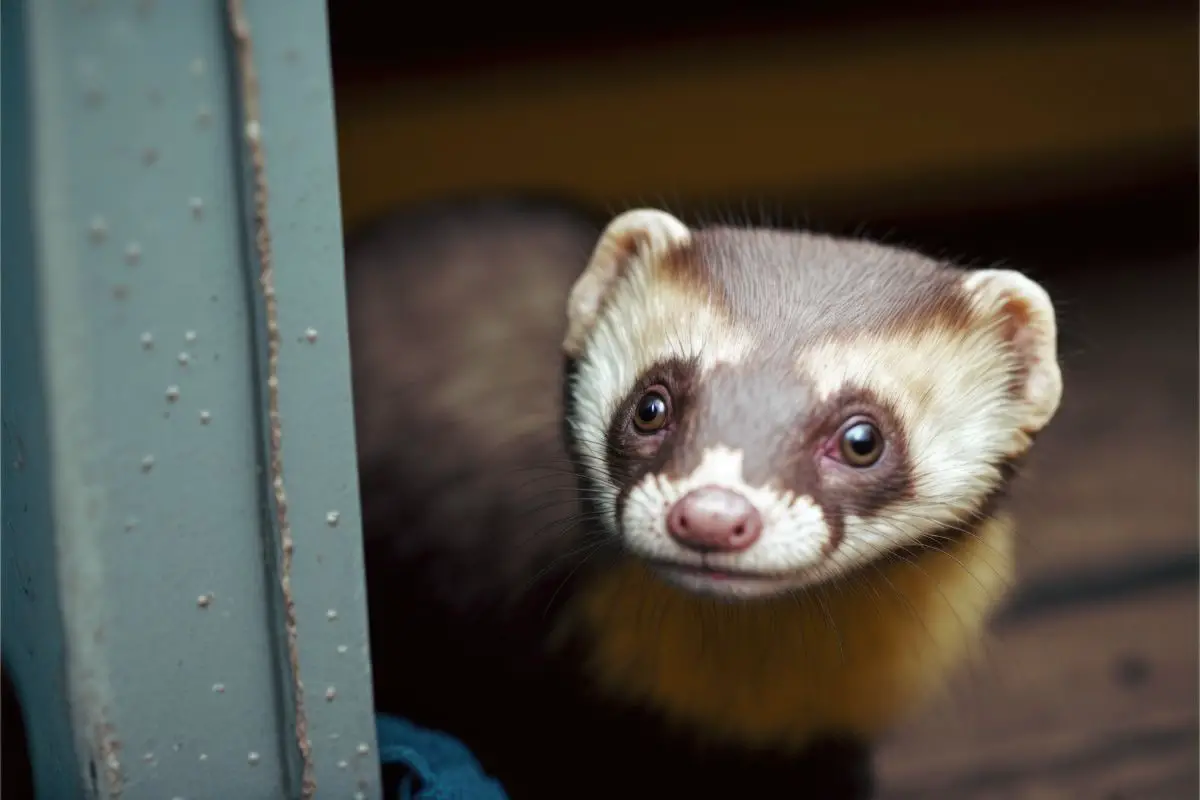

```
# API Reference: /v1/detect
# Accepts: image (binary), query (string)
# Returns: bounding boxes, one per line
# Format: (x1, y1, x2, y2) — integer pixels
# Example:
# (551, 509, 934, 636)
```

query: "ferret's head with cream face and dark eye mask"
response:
(564, 210, 1062, 597)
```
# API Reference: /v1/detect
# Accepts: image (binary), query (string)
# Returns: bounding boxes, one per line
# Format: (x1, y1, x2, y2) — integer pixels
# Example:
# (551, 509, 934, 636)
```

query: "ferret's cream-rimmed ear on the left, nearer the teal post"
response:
(563, 209, 691, 359)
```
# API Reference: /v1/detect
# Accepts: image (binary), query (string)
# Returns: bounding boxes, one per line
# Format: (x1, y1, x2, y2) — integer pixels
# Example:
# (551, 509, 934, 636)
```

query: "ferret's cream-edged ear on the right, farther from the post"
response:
(965, 270, 1062, 434)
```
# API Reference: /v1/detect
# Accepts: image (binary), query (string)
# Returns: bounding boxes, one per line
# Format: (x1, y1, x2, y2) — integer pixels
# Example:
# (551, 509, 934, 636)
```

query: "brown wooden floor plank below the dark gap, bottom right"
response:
(880, 583, 1200, 800)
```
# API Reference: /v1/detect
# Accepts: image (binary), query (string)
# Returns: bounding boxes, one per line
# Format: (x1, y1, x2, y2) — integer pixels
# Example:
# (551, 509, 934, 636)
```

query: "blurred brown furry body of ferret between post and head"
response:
(347, 200, 599, 608)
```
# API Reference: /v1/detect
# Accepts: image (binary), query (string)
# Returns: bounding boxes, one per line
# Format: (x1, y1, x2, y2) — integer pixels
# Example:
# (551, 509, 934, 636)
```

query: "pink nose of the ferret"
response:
(667, 486, 762, 553)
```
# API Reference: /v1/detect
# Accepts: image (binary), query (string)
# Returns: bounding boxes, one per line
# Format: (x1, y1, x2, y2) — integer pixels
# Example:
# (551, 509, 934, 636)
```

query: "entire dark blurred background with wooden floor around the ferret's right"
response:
(330, 0, 1200, 800)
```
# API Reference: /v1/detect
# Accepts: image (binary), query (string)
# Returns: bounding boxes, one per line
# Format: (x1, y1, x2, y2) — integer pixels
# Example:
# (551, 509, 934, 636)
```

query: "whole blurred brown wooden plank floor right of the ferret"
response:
(878, 248, 1200, 800)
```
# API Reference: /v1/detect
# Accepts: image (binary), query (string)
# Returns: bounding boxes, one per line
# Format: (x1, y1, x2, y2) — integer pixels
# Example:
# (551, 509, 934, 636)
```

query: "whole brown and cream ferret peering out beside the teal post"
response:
(347, 198, 1062, 800)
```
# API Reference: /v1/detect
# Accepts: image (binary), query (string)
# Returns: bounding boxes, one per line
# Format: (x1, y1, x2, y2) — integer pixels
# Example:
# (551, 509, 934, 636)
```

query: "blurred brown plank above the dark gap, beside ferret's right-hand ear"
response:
(1014, 253, 1200, 579)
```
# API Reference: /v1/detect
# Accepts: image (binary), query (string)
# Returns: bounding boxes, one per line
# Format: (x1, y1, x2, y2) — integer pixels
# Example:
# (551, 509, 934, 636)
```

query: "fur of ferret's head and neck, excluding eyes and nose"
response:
(562, 210, 1061, 762)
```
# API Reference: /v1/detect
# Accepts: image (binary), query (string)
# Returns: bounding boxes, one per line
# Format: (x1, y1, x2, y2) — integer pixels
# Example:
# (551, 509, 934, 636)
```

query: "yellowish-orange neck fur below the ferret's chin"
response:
(560, 518, 1013, 748)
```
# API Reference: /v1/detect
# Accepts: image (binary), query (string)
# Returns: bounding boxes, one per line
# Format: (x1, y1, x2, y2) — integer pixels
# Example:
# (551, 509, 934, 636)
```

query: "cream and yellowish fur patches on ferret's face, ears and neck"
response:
(559, 216, 1062, 747)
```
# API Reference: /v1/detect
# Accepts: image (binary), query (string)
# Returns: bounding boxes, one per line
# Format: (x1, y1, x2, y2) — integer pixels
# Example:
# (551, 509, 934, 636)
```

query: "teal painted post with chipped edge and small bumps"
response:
(0, 0, 379, 800)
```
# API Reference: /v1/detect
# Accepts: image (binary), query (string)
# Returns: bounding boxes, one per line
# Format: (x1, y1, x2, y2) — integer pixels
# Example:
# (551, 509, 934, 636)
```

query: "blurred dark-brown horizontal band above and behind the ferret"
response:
(335, 2, 1198, 231)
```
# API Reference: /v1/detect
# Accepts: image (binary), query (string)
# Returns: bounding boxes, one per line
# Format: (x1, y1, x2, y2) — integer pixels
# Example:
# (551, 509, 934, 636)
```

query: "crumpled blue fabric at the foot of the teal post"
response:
(376, 714, 508, 800)
